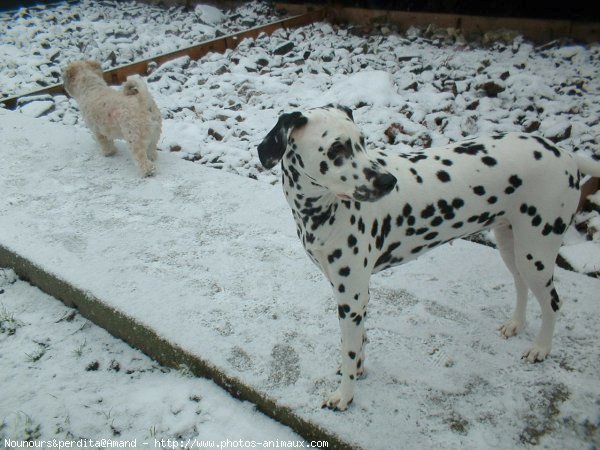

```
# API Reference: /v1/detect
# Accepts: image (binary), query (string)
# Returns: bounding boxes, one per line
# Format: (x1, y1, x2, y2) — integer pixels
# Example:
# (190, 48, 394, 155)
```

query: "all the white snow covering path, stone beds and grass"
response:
(0, 0, 600, 449)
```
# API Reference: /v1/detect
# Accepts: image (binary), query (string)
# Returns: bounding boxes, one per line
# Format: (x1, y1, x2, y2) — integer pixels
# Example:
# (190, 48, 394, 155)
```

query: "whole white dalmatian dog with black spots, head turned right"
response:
(258, 105, 600, 410)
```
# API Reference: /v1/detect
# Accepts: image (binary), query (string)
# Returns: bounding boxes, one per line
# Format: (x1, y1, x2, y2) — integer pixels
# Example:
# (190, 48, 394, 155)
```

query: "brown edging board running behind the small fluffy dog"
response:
(0, 9, 325, 109)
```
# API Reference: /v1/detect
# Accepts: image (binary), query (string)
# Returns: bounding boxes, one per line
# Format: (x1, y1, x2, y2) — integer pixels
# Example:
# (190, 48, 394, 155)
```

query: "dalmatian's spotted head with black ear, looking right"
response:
(258, 105, 397, 202)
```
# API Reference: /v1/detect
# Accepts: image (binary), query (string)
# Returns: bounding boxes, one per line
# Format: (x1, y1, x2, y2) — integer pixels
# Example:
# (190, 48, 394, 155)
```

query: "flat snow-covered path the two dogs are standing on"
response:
(0, 111, 600, 449)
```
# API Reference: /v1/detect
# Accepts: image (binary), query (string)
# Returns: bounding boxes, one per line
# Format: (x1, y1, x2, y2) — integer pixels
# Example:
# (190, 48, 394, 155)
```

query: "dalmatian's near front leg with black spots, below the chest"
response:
(323, 279, 369, 411)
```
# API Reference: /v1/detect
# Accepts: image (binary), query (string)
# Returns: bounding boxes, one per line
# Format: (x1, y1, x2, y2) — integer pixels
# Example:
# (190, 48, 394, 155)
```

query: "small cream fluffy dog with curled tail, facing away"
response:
(63, 61, 162, 176)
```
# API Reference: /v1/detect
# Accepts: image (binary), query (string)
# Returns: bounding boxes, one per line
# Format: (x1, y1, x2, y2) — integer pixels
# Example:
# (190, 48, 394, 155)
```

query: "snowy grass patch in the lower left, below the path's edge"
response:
(0, 268, 304, 448)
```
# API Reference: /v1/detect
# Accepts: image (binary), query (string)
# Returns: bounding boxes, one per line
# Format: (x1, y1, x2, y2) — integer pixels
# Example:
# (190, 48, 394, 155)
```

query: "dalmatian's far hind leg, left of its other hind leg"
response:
(494, 224, 528, 338)
